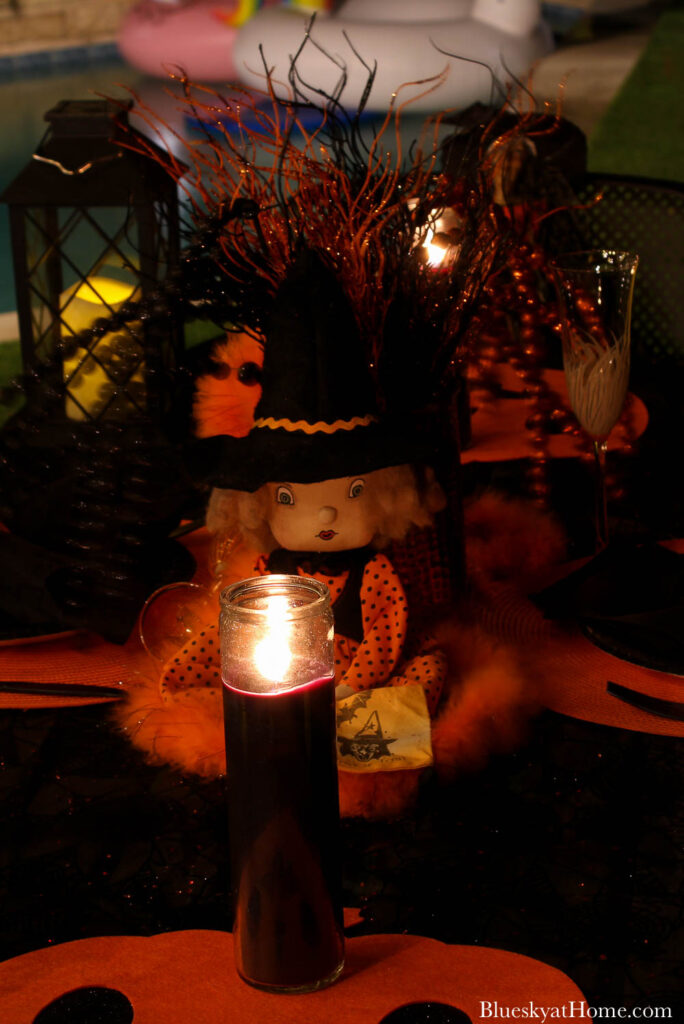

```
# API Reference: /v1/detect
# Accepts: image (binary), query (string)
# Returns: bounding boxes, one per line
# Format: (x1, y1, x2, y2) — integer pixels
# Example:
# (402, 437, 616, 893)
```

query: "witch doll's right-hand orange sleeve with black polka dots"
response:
(333, 554, 409, 690)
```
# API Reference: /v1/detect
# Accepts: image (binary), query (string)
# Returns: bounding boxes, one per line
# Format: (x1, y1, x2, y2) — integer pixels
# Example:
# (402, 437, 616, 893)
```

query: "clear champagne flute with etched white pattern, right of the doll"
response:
(551, 249, 639, 550)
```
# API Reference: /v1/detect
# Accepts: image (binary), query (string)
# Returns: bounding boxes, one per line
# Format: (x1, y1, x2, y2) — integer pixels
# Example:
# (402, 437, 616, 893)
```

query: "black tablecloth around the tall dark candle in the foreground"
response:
(0, 706, 684, 1019)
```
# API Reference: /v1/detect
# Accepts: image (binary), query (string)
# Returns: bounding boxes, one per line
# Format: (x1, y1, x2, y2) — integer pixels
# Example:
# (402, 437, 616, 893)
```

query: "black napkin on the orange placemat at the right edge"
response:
(531, 542, 684, 675)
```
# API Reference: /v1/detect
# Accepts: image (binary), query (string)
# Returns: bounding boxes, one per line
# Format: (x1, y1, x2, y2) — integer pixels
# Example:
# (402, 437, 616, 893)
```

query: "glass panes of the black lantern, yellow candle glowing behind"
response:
(21, 204, 178, 420)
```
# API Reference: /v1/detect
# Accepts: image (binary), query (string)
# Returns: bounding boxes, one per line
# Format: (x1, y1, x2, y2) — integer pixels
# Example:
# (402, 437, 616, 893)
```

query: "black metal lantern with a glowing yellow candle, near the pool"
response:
(2, 99, 182, 422)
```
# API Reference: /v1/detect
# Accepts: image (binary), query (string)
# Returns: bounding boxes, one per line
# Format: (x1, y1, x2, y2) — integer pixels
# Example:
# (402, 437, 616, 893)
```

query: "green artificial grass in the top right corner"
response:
(589, 5, 684, 182)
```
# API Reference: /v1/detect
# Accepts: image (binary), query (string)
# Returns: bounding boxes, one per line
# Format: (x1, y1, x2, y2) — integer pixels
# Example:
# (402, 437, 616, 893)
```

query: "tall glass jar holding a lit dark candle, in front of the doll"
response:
(220, 575, 344, 992)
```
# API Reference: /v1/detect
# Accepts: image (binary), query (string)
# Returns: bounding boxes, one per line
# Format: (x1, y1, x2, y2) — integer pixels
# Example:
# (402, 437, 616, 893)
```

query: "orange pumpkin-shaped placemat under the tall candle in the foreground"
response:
(0, 931, 586, 1024)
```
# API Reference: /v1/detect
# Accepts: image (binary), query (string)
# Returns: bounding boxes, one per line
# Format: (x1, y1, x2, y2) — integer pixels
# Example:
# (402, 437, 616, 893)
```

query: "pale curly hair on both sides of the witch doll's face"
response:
(207, 465, 445, 553)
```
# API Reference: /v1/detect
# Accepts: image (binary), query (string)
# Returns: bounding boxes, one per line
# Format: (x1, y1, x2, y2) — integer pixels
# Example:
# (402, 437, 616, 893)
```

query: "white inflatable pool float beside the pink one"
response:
(232, 0, 553, 112)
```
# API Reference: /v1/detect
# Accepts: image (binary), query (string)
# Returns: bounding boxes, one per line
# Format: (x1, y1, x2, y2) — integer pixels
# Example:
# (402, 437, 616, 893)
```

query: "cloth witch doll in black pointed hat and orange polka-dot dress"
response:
(198, 248, 444, 713)
